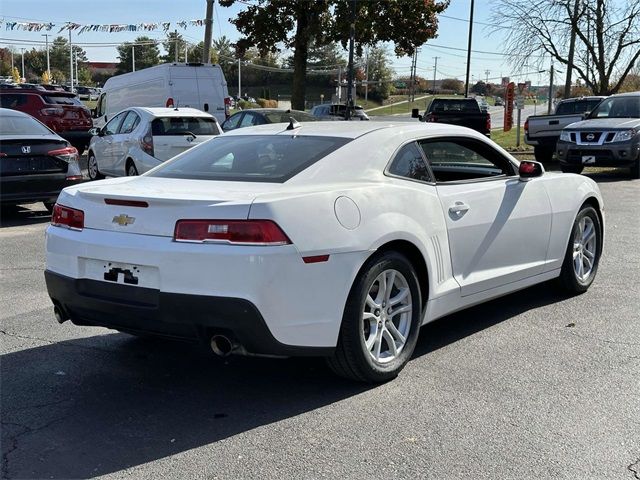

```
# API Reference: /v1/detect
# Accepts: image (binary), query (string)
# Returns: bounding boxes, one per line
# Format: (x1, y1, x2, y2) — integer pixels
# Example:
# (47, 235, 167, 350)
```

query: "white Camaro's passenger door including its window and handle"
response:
(419, 138, 551, 297)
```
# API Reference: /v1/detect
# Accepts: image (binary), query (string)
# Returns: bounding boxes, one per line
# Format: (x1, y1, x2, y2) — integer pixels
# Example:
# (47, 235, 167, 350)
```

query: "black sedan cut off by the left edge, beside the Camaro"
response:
(0, 108, 82, 210)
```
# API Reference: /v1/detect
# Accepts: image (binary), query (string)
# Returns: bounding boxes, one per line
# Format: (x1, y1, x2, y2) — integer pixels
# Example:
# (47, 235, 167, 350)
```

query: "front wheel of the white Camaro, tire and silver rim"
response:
(559, 205, 602, 293)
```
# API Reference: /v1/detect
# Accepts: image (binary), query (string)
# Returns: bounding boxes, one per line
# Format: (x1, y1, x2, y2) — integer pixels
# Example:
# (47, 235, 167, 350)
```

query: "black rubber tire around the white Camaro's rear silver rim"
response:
(327, 251, 422, 383)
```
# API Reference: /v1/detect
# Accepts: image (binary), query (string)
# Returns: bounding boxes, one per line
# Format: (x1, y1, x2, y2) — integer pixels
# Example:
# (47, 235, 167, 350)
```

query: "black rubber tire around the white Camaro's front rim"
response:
(558, 205, 602, 294)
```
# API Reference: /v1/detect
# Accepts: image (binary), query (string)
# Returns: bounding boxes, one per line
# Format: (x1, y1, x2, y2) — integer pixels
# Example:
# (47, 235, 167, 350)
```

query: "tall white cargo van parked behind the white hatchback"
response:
(93, 63, 231, 127)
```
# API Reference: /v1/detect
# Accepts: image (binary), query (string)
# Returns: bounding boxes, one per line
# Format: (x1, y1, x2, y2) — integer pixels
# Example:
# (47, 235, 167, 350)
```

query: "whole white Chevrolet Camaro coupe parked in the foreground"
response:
(45, 121, 604, 382)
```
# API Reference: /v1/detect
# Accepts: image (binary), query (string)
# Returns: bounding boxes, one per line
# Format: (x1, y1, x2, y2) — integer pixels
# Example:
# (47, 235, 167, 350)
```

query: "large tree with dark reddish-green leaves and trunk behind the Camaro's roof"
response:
(220, 0, 449, 109)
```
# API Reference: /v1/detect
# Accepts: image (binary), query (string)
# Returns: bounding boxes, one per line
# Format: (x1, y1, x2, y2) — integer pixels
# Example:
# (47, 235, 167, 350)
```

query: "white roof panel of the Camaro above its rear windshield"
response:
(225, 121, 481, 139)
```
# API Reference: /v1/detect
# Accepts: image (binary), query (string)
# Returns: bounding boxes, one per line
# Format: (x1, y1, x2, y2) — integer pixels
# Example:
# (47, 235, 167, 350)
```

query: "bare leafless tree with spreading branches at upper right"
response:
(494, 0, 640, 95)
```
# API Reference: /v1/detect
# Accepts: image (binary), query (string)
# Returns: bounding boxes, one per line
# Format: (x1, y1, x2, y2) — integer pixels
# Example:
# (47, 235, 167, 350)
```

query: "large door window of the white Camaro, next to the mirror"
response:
(419, 138, 515, 182)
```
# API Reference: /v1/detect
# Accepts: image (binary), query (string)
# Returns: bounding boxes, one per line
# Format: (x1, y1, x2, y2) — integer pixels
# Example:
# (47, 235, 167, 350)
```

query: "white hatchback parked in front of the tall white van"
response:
(87, 107, 222, 180)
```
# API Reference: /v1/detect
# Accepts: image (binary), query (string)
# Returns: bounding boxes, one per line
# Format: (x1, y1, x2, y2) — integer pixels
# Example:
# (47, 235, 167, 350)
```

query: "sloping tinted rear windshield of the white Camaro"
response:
(150, 135, 350, 183)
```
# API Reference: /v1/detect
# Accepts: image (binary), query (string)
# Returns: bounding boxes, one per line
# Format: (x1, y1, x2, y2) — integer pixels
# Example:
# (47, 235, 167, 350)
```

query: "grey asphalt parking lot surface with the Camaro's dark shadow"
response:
(0, 171, 640, 479)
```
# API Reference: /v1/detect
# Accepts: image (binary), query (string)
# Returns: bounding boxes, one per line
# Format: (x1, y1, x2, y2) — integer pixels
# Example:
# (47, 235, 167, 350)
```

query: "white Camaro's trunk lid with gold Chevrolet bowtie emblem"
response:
(58, 176, 281, 237)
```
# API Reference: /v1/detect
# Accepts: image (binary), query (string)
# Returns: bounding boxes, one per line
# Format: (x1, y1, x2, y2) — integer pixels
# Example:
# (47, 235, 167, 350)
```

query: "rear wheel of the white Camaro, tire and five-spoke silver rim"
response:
(328, 252, 421, 382)
